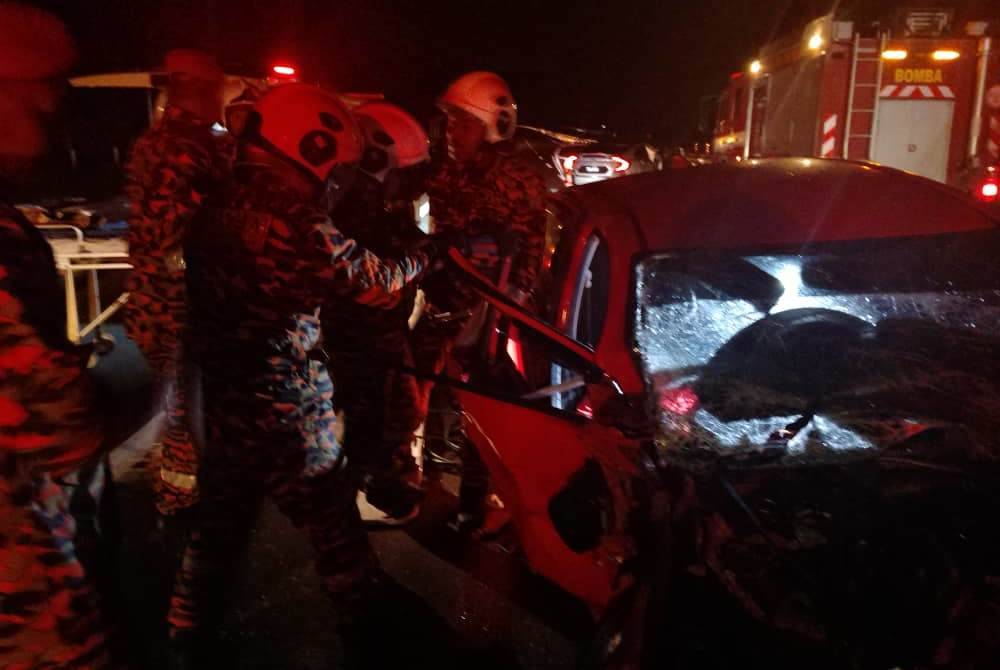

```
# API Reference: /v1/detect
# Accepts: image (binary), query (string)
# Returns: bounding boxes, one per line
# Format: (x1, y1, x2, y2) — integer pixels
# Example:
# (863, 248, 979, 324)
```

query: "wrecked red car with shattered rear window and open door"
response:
(436, 159, 1000, 668)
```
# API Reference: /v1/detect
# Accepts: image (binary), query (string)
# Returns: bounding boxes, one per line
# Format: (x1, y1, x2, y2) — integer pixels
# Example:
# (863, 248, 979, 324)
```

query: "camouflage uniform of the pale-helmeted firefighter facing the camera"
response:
(411, 149, 546, 524)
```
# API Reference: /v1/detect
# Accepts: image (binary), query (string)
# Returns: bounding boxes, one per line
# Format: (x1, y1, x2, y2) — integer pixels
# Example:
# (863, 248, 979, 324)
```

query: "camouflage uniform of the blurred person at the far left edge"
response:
(0, 205, 109, 670)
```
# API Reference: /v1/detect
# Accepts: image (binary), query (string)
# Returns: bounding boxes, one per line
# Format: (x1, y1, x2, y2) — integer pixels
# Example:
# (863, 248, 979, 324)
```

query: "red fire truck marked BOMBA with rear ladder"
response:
(713, 3, 1000, 188)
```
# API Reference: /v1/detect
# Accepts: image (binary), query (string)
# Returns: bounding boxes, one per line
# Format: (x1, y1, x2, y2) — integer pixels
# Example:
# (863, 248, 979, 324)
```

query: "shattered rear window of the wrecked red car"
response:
(635, 231, 1000, 470)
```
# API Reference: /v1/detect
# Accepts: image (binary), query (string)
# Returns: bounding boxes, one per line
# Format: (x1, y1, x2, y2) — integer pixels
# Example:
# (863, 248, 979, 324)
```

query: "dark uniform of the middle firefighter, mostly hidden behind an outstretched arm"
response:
(322, 182, 423, 506)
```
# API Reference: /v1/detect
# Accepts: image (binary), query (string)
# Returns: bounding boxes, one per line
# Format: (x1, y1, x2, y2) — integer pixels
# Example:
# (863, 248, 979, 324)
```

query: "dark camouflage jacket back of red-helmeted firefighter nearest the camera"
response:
(188, 173, 323, 376)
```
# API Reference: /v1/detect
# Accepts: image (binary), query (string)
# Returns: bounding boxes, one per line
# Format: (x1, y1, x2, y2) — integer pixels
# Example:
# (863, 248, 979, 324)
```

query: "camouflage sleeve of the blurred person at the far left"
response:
(0, 265, 101, 476)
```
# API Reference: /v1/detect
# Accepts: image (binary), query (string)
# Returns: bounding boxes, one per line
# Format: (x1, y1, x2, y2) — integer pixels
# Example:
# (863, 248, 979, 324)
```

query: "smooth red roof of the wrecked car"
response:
(568, 158, 1000, 251)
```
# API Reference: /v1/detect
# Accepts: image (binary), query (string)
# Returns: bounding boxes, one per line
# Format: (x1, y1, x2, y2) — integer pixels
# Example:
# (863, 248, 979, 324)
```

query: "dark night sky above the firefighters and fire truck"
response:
(23, 0, 884, 142)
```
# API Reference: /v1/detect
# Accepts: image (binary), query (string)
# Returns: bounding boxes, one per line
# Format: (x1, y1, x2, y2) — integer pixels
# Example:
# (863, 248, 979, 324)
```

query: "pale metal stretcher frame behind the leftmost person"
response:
(37, 223, 132, 354)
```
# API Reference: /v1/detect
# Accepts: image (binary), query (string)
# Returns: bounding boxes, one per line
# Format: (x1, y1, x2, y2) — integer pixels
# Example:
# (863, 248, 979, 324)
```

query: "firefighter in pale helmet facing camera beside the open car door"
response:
(412, 72, 545, 530)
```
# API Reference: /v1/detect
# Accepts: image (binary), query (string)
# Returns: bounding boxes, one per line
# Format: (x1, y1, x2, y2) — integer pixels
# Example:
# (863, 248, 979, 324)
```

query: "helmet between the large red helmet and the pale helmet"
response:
(354, 102, 430, 181)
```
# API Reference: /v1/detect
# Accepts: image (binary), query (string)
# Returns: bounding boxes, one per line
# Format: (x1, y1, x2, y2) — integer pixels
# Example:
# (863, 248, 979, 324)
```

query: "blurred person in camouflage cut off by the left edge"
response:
(0, 2, 110, 668)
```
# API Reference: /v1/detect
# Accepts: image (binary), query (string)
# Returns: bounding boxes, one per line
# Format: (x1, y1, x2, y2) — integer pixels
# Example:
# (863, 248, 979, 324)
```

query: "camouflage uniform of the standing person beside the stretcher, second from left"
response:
(125, 106, 232, 514)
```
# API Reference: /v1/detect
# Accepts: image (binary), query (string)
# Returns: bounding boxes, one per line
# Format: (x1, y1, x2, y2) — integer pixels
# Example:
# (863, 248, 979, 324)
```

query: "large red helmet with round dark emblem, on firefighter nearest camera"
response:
(248, 84, 363, 189)
